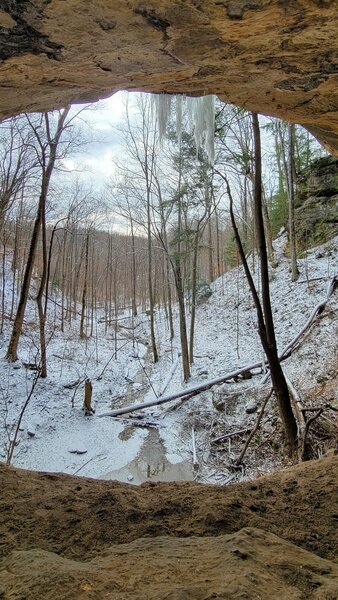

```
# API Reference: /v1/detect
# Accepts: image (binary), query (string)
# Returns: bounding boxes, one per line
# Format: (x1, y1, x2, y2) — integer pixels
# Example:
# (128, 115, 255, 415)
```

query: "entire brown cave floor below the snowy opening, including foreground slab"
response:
(0, 455, 338, 600)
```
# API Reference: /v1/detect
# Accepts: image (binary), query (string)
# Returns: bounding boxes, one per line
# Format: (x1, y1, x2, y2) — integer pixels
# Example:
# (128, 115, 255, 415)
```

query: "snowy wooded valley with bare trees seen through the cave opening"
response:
(0, 94, 338, 484)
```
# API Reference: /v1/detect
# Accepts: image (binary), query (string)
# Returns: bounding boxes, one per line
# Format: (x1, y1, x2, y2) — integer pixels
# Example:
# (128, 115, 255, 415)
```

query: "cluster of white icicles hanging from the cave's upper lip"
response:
(152, 94, 215, 165)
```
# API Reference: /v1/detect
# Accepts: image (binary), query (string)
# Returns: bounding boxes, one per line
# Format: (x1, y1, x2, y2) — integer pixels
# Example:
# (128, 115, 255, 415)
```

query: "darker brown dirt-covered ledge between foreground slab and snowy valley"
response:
(0, 455, 338, 560)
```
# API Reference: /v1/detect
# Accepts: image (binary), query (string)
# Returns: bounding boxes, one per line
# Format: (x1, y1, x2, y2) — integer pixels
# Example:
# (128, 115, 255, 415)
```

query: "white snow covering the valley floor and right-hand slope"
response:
(0, 235, 338, 483)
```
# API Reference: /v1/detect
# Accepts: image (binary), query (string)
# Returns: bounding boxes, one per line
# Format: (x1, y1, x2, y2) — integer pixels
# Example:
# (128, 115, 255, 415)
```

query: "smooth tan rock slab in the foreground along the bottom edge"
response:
(0, 528, 338, 600)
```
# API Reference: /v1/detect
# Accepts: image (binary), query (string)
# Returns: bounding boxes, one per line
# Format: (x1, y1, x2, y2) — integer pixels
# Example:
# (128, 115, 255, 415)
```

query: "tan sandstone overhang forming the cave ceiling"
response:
(0, 0, 338, 153)
